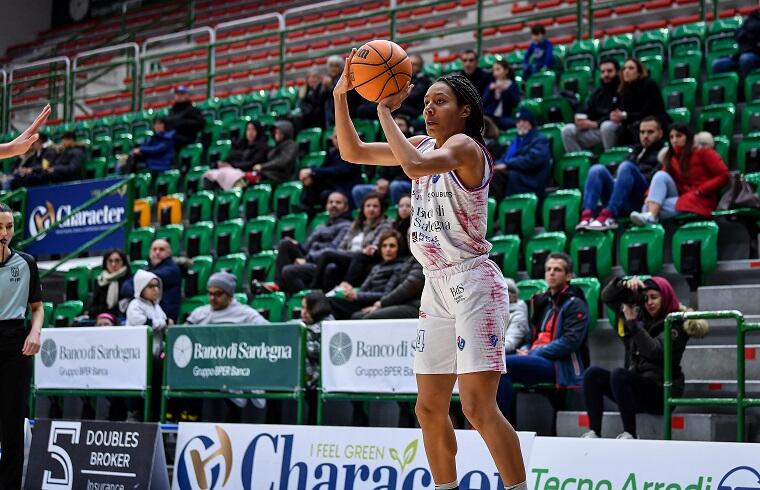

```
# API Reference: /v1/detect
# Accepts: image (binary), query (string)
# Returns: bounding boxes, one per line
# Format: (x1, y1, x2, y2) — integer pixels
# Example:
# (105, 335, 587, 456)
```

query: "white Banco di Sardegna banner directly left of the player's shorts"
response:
(321, 319, 417, 393)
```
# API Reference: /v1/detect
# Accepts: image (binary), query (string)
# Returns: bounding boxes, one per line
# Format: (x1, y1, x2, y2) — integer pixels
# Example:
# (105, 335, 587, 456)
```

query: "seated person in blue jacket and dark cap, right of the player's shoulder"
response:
(490, 109, 552, 201)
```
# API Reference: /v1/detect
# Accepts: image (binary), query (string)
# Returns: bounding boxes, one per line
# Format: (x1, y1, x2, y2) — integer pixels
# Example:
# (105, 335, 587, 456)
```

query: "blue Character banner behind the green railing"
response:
(24, 178, 130, 255)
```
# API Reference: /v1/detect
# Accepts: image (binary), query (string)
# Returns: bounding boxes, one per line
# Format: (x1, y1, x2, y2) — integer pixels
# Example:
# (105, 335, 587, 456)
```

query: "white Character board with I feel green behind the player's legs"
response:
(172, 423, 536, 490)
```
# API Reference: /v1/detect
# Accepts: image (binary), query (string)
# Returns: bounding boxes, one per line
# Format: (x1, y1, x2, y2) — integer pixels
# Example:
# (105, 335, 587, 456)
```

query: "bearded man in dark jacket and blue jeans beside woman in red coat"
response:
(576, 116, 665, 231)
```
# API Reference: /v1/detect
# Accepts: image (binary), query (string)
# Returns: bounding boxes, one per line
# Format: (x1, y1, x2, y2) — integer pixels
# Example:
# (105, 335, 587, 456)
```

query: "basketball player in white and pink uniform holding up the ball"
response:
(333, 50, 527, 490)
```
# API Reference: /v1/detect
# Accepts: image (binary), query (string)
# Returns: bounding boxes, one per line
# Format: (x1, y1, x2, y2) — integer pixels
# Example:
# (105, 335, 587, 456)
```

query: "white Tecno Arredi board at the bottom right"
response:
(528, 437, 760, 490)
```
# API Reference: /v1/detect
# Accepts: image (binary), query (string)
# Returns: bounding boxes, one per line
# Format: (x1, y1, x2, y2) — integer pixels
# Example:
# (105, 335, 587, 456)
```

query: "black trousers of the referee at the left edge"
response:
(0, 336, 33, 490)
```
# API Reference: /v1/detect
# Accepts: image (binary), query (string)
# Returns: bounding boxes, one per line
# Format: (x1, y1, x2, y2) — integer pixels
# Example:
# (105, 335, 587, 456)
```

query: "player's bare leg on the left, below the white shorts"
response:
(415, 374, 457, 485)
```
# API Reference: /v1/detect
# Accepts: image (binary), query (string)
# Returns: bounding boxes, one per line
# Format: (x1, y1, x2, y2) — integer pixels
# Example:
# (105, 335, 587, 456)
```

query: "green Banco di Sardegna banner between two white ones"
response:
(165, 323, 302, 391)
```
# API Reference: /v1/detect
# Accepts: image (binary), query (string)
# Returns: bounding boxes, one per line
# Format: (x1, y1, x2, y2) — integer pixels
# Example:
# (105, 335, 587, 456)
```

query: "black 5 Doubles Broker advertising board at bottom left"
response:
(24, 419, 169, 490)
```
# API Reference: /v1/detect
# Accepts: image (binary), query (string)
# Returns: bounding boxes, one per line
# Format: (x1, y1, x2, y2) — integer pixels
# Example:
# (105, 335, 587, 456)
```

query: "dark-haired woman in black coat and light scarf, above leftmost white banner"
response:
(89, 249, 132, 318)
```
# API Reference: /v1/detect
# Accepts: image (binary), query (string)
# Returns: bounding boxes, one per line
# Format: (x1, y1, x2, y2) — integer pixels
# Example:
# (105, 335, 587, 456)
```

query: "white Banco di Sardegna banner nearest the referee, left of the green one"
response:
(34, 327, 150, 390)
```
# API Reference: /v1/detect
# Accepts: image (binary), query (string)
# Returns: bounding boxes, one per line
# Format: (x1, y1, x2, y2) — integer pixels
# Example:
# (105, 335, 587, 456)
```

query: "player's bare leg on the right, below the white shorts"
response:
(459, 371, 525, 487)
